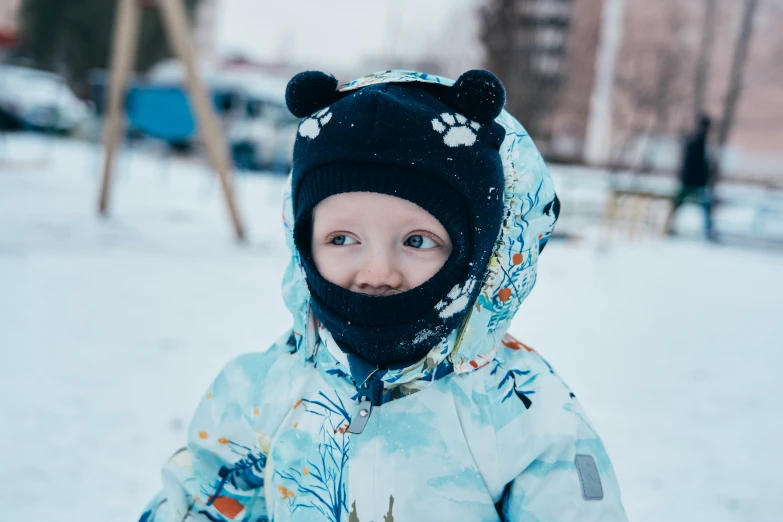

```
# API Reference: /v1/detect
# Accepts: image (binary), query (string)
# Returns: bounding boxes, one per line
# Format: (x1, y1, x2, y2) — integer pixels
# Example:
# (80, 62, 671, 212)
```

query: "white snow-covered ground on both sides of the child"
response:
(0, 136, 783, 522)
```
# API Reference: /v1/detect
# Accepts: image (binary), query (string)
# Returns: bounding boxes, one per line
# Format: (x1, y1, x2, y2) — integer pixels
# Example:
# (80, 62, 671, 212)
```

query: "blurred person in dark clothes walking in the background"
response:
(666, 114, 717, 241)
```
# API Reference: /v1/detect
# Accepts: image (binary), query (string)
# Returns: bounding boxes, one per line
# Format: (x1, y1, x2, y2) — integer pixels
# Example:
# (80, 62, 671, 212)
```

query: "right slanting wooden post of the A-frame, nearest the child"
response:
(160, 0, 245, 240)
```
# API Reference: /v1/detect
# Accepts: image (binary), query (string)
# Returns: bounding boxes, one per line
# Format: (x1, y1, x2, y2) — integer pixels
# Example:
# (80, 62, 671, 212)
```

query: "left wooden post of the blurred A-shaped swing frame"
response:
(98, 0, 141, 215)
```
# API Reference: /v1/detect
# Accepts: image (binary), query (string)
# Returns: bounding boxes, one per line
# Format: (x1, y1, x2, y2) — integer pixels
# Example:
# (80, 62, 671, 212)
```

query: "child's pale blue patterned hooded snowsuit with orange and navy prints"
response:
(141, 71, 626, 522)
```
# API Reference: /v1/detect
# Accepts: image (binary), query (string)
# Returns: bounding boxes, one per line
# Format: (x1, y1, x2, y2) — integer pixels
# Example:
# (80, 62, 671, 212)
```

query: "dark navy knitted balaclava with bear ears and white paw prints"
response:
(286, 71, 505, 367)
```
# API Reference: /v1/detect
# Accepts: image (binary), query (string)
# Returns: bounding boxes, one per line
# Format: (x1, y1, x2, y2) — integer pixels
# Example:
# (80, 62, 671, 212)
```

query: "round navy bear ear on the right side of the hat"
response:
(451, 69, 506, 124)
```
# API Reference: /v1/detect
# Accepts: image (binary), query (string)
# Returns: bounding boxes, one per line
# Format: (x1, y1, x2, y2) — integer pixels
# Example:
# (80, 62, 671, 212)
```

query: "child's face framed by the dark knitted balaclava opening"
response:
(312, 192, 451, 295)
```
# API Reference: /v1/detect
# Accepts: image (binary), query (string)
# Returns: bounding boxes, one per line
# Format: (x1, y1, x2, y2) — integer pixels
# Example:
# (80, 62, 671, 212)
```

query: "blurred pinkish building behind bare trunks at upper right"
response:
(548, 0, 783, 180)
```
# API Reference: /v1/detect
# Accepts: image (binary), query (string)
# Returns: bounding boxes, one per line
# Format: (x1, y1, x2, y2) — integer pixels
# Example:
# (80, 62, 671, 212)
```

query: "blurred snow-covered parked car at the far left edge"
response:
(0, 65, 90, 133)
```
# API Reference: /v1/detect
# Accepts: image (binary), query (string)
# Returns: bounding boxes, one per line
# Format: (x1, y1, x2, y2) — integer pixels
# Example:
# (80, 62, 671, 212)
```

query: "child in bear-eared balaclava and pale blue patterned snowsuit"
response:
(141, 71, 626, 522)
